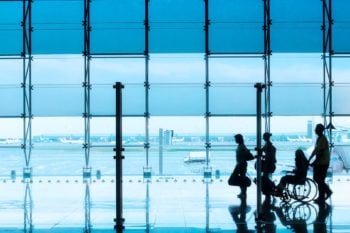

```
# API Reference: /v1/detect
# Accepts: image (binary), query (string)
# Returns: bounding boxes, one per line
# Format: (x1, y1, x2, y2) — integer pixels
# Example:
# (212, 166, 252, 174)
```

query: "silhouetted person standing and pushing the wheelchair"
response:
(309, 124, 332, 202)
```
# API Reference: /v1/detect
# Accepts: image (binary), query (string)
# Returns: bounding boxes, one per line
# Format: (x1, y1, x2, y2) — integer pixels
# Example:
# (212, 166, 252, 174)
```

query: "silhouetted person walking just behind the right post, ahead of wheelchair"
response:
(261, 132, 276, 200)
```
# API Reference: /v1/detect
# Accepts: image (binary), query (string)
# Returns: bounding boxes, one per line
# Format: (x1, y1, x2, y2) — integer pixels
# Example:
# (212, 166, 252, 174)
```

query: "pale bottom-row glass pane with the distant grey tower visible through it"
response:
(149, 117, 205, 175)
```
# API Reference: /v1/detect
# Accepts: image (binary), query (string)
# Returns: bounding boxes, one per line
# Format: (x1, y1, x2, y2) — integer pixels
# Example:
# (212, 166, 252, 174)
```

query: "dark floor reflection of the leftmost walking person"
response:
(228, 198, 255, 233)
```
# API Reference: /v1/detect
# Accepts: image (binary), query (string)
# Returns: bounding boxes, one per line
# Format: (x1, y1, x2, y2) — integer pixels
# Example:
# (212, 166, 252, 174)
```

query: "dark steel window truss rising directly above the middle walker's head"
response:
(263, 0, 272, 132)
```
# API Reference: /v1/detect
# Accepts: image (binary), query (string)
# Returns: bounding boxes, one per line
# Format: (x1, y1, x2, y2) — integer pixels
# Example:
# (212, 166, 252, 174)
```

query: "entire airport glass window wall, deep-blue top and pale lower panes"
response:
(0, 0, 350, 180)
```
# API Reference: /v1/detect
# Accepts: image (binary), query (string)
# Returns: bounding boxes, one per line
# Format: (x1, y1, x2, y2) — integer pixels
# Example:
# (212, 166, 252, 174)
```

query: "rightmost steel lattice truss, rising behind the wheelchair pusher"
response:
(321, 0, 334, 145)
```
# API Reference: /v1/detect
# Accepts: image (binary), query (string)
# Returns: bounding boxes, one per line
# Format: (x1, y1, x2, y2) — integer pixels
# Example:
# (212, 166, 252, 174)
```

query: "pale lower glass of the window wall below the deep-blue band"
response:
(1, 54, 350, 176)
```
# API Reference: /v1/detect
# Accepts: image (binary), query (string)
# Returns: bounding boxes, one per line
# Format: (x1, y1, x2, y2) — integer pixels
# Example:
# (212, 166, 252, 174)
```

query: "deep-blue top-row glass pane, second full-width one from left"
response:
(90, 0, 145, 53)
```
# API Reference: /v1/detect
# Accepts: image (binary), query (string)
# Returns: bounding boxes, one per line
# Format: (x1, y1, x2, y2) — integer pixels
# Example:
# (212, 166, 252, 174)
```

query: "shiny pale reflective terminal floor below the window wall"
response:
(0, 176, 350, 233)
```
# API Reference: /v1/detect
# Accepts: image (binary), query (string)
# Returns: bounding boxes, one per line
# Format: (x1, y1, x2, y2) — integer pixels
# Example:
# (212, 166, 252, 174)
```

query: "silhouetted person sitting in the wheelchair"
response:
(277, 149, 309, 191)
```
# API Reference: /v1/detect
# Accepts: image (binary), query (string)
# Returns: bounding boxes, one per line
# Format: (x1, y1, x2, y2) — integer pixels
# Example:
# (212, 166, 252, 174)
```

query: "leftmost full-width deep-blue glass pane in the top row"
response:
(32, 1, 84, 54)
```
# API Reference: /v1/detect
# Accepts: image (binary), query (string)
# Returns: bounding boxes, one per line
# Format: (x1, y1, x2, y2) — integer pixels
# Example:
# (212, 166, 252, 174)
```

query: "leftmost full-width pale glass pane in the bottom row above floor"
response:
(31, 117, 85, 176)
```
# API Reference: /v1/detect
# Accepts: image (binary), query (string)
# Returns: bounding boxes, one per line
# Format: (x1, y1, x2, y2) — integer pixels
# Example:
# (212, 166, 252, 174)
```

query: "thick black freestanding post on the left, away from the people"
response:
(113, 82, 124, 232)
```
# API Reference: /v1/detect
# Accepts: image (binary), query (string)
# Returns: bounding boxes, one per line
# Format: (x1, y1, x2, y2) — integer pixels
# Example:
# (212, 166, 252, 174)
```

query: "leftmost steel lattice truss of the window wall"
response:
(21, 0, 33, 178)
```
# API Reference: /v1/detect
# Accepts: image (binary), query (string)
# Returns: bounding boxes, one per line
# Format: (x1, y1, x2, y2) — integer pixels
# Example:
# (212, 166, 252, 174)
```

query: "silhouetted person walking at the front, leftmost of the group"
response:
(228, 134, 254, 198)
